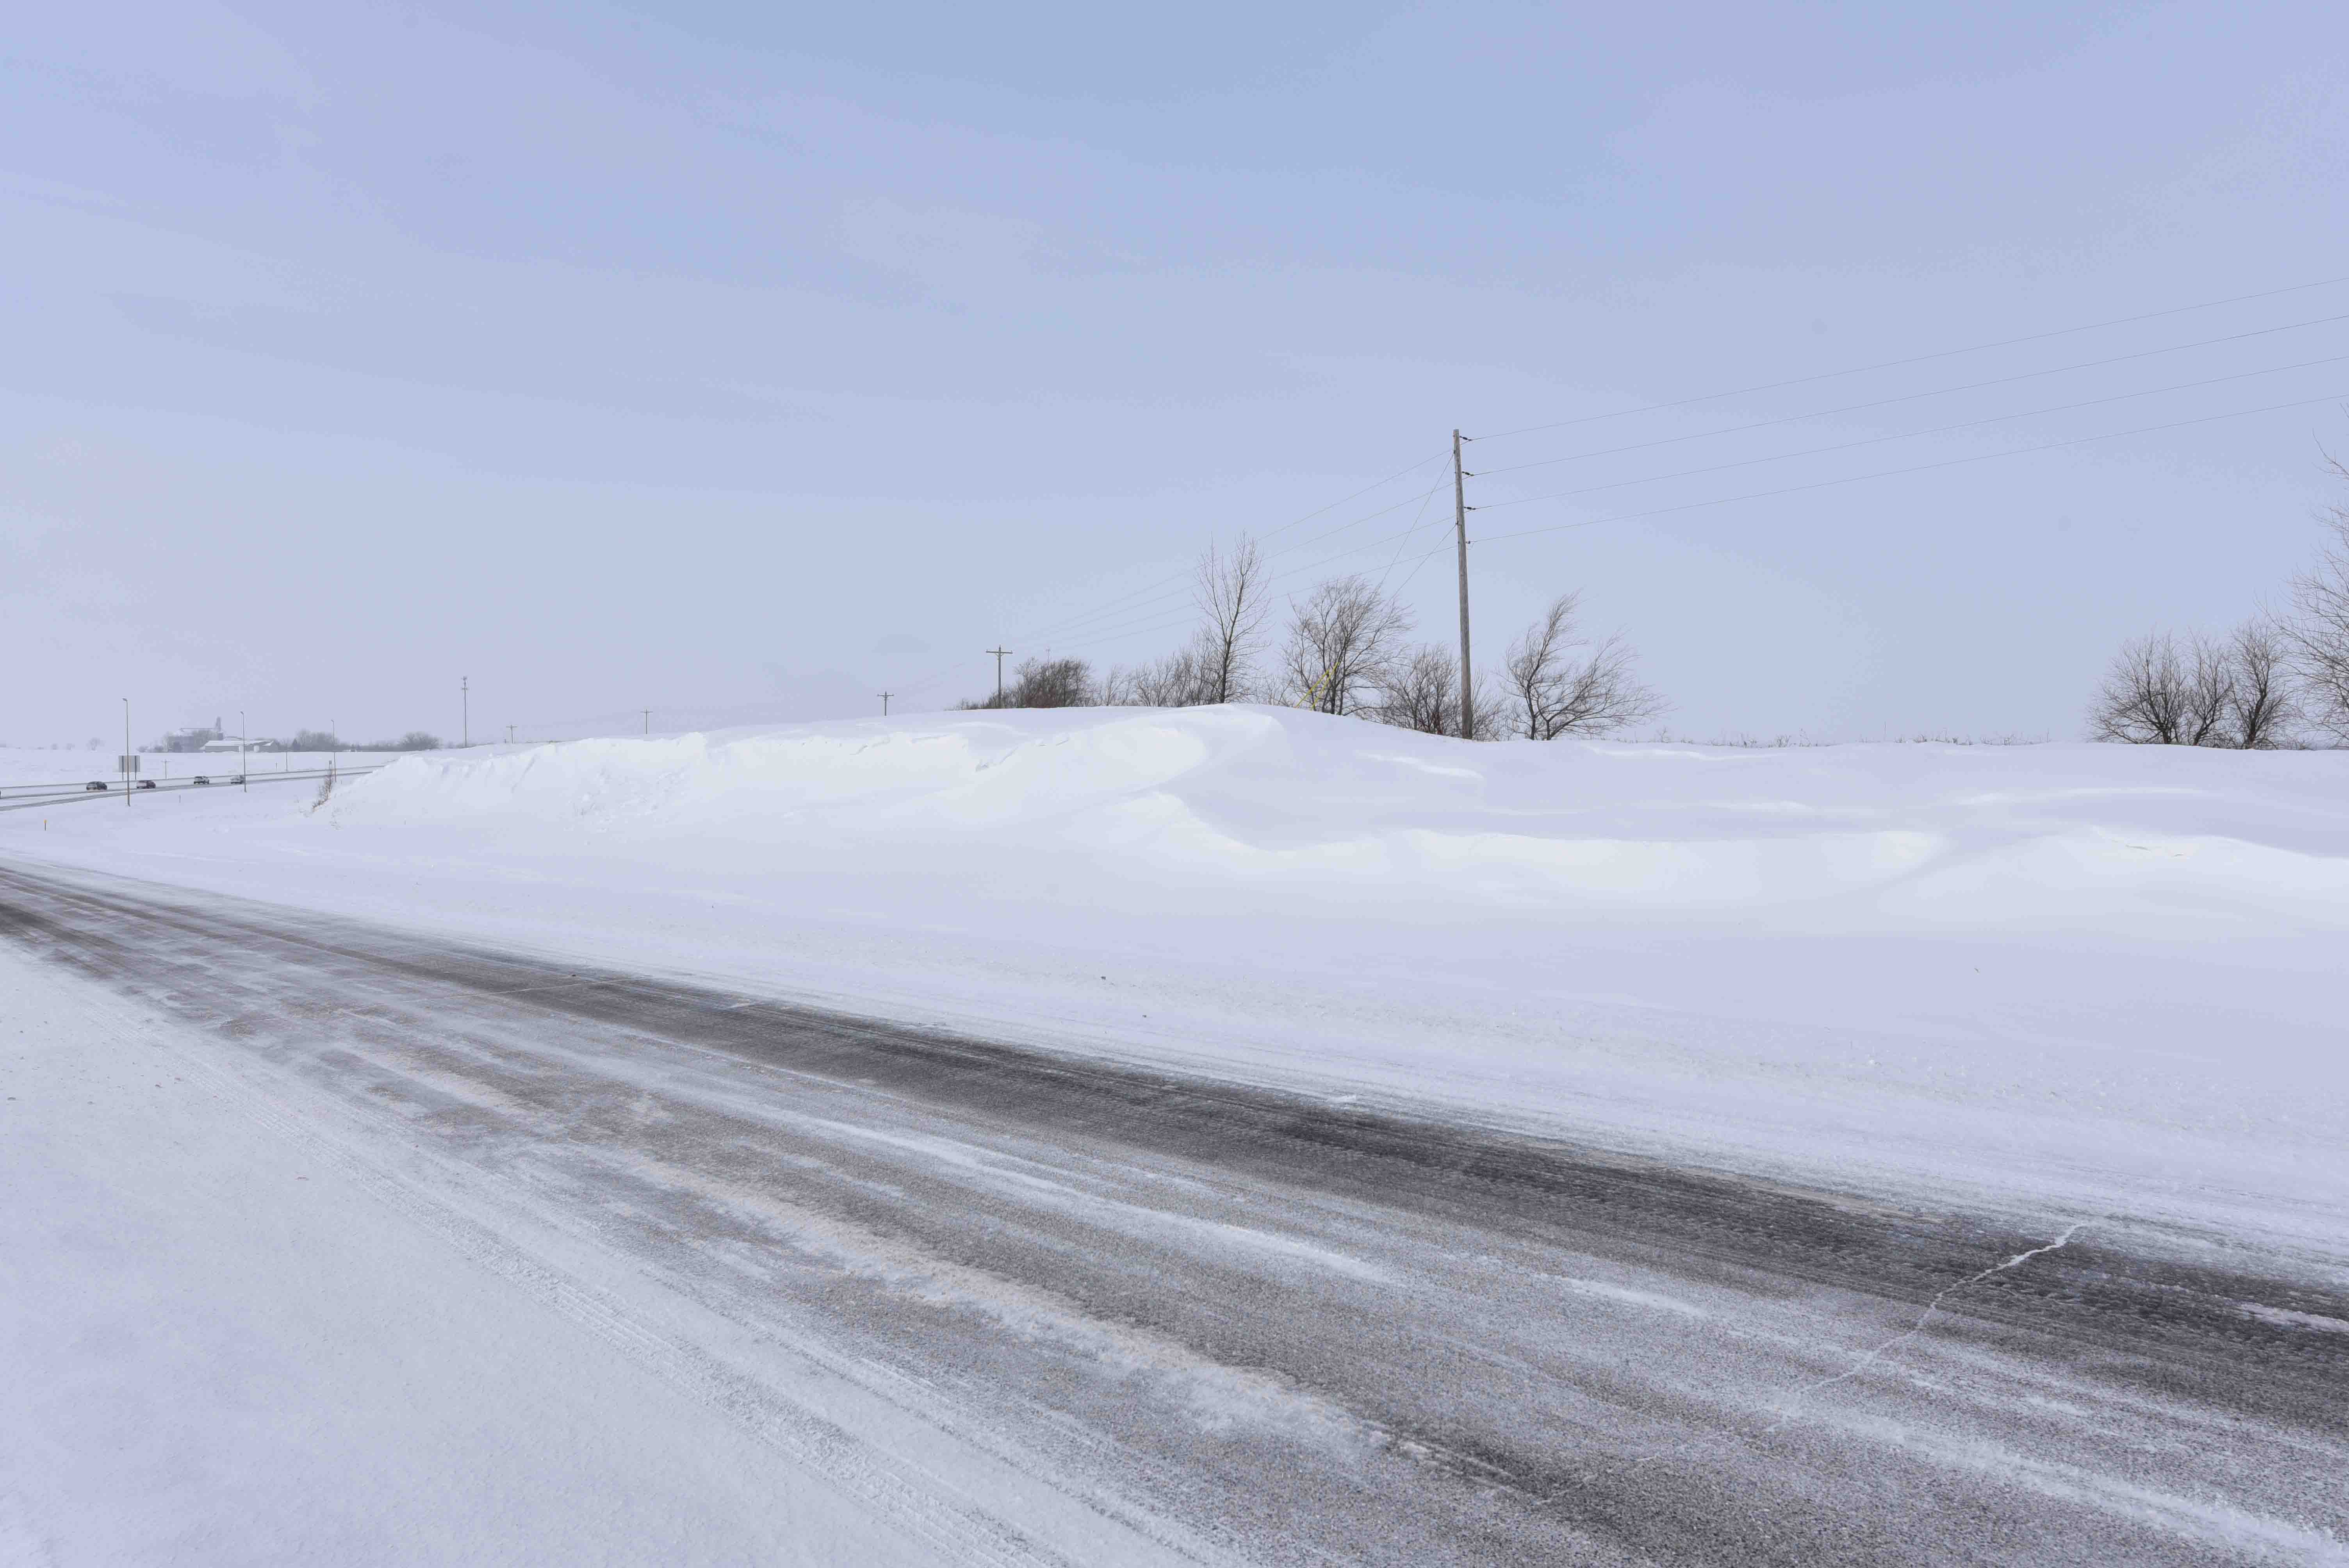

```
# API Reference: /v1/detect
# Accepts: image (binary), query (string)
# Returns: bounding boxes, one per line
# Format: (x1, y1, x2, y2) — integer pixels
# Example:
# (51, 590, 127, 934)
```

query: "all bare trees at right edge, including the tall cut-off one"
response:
(2088, 460, 2349, 751)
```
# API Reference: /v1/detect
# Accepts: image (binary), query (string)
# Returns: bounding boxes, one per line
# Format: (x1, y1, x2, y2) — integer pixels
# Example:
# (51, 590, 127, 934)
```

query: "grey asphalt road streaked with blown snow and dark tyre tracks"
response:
(0, 866, 2349, 1563)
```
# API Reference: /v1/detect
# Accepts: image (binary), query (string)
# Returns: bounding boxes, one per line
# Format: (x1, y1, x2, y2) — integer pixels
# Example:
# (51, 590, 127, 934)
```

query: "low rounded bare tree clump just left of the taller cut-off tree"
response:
(2088, 617, 2297, 749)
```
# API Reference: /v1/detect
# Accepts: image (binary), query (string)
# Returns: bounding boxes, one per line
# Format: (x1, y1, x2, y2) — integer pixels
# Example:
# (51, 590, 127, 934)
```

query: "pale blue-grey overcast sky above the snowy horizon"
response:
(0, 0, 2349, 744)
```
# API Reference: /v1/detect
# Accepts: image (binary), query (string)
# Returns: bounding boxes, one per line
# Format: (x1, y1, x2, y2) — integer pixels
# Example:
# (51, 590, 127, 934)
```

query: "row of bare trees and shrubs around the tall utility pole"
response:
(966, 538, 1665, 739)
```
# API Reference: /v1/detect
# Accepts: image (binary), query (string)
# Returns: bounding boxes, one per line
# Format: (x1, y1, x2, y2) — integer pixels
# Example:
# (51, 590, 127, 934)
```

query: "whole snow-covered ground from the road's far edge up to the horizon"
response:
(0, 707, 2349, 1246)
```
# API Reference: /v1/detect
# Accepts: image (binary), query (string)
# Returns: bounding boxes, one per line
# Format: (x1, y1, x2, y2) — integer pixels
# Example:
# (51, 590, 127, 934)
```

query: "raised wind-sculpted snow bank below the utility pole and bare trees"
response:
(329, 707, 2349, 941)
